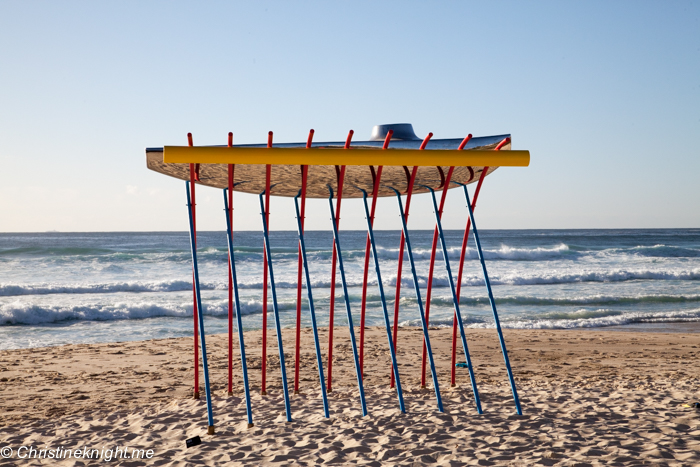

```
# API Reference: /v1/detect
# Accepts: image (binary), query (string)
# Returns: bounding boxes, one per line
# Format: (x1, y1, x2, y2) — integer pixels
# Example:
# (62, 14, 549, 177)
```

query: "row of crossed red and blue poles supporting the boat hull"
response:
(185, 130, 522, 434)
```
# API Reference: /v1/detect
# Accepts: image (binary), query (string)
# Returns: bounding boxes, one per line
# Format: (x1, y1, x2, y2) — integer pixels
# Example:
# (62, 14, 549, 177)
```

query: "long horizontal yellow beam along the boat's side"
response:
(163, 146, 530, 167)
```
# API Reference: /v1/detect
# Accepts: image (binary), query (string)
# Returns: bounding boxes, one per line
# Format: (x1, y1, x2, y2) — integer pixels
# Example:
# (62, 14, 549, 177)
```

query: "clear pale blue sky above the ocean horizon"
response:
(0, 0, 700, 232)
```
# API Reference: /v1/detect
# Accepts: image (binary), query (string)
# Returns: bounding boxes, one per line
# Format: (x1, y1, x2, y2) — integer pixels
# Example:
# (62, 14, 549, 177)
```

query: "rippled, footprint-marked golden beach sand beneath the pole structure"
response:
(0, 327, 700, 466)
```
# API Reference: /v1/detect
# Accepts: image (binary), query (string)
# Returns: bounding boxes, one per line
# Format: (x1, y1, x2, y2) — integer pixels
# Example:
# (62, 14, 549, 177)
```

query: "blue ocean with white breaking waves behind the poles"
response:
(0, 229, 700, 349)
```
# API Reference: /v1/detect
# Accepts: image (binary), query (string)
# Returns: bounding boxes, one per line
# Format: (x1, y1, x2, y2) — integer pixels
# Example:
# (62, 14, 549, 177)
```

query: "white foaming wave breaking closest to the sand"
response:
(0, 295, 700, 329)
